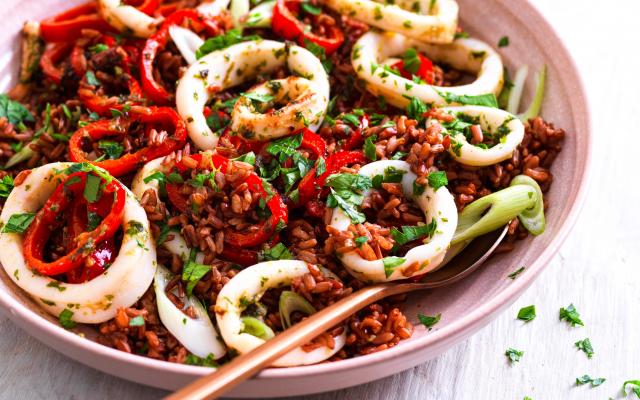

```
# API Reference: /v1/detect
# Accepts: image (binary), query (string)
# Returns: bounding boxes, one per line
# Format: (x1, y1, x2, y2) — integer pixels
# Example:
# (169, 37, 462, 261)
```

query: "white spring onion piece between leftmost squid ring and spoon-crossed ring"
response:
(153, 265, 226, 359)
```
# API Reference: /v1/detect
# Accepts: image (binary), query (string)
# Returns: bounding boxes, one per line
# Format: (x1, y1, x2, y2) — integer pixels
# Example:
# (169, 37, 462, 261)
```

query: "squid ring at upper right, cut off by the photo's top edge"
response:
(325, 0, 458, 43)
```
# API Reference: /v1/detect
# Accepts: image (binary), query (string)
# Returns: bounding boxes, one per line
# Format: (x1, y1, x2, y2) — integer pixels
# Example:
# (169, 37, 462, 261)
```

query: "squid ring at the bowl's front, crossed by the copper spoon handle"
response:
(215, 260, 347, 367)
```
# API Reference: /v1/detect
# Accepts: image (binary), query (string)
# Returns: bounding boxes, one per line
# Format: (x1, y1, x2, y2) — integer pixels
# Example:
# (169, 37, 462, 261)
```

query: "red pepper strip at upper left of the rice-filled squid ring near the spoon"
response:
(297, 151, 367, 205)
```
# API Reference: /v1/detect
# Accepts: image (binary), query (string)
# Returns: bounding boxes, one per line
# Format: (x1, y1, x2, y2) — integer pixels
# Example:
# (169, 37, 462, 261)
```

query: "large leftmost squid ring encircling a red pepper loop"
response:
(0, 163, 157, 324)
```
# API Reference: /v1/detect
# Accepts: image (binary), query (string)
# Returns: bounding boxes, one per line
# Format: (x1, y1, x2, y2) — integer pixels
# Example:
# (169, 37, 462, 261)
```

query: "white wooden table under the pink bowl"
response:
(0, 0, 640, 400)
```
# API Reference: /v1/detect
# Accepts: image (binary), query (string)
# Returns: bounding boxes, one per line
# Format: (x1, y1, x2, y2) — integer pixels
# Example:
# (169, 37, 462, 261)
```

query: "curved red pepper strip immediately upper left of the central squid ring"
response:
(140, 9, 220, 105)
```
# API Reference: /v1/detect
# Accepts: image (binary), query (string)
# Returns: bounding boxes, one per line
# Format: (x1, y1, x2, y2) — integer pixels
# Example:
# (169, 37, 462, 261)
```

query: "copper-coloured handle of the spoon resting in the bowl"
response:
(166, 284, 398, 400)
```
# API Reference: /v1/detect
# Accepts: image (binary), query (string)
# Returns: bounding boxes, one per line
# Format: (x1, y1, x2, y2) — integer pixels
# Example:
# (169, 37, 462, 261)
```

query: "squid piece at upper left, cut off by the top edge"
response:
(98, 0, 158, 38)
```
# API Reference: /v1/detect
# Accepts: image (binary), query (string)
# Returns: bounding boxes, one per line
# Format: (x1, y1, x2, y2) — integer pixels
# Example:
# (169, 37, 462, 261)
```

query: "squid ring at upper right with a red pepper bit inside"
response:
(351, 32, 504, 108)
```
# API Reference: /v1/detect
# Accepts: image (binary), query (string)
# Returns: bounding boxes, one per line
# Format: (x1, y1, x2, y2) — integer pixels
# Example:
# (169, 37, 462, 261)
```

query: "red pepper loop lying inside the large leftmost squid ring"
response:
(22, 172, 126, 276)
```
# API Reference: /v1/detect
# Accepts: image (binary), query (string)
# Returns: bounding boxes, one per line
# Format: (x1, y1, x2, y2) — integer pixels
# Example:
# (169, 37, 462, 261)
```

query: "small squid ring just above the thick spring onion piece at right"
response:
(440, 106, 524, 167)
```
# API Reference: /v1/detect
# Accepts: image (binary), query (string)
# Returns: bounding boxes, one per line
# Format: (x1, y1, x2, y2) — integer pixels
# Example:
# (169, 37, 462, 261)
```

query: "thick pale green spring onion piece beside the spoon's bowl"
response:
(451, 175, 545, 245)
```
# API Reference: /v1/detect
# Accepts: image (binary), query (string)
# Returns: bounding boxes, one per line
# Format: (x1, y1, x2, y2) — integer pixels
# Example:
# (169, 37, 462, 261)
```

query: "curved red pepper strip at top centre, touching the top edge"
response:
(271, 0, 344, 55)
